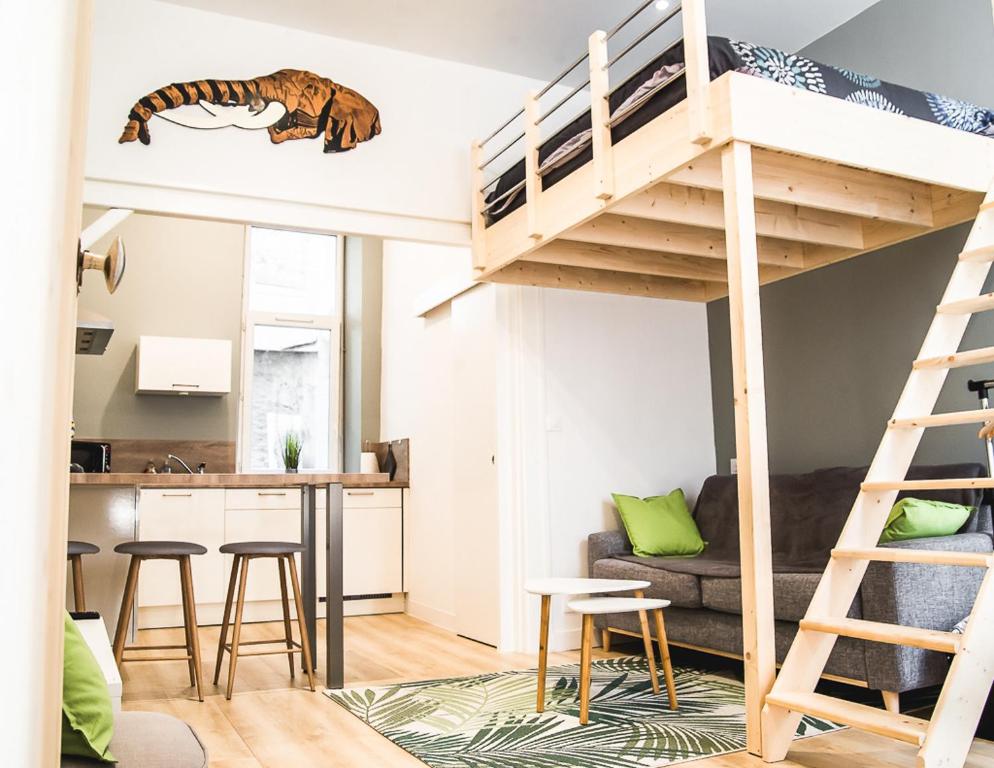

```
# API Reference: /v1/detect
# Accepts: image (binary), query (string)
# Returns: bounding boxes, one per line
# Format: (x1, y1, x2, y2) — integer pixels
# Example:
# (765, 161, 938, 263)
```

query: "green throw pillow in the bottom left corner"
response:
(62, 613, 117, 763)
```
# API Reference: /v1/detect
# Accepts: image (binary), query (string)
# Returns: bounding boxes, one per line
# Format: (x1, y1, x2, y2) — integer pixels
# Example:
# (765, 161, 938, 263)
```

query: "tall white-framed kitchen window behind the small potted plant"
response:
(239, 227, 342, 471)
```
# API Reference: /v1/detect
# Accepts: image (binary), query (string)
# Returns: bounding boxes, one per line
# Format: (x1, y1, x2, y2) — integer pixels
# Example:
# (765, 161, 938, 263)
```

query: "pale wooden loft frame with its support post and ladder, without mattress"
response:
(472, 0, 994, 768)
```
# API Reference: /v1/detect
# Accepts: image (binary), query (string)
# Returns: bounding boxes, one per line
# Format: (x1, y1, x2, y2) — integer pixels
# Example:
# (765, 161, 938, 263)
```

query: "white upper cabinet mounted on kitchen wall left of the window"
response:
(135, 336, 231, 396)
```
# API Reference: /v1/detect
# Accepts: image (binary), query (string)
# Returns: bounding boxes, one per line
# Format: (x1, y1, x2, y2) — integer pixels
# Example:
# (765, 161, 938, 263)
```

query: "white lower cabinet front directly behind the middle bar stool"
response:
(138, 488, 225, 612)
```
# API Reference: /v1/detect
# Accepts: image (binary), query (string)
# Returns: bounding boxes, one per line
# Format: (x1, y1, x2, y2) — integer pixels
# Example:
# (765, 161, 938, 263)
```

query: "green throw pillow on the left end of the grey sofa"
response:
(612, 488, 705, 557)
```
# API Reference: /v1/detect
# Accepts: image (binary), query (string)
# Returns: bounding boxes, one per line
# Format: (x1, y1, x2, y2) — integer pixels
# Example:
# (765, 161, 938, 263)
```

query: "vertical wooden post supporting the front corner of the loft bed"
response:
(721, 142, 776, 755)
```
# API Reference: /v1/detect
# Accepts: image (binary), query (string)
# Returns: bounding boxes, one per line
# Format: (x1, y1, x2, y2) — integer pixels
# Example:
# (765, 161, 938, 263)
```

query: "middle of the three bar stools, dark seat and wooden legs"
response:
(114, 541, 207, 701)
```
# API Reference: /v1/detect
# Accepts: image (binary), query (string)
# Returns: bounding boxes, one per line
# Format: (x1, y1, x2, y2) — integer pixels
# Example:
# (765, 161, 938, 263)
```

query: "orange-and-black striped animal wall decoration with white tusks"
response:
(118, 69, 381, 152)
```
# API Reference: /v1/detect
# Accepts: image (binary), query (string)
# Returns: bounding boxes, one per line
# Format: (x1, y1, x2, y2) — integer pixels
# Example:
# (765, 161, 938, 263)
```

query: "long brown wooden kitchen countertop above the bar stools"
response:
(69, 472, 407, 488)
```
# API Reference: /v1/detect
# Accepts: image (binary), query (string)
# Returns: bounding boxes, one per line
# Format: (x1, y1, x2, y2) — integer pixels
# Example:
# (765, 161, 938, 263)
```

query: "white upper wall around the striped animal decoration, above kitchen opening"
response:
(86, 0, 552, 231)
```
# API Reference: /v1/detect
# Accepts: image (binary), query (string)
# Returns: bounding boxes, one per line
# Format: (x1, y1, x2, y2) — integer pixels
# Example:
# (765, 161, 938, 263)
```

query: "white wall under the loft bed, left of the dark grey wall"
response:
(502, 289, 715, 650)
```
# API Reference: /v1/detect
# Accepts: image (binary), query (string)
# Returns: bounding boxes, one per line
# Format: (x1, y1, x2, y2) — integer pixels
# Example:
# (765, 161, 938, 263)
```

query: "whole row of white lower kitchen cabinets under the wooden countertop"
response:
(138, 488, 404, 629)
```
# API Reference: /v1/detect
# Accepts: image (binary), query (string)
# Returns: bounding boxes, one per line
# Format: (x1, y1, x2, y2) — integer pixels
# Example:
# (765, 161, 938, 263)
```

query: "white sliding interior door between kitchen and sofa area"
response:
(452, 285, 500, 646)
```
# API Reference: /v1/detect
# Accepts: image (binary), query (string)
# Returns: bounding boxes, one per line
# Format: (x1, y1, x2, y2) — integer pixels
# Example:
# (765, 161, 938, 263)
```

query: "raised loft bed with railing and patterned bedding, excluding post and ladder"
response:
(472, 0, 994, 301)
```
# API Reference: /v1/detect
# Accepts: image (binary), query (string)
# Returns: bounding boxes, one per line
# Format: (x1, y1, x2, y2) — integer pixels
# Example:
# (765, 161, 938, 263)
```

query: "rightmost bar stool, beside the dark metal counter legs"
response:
(214, 541, 314, 700)
